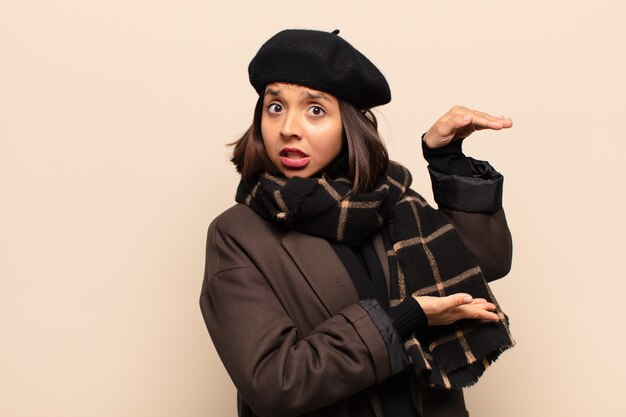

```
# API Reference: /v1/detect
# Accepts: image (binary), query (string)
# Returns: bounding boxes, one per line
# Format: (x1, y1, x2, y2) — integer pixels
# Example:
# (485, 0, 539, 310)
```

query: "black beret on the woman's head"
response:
(248, 29, 391, 109)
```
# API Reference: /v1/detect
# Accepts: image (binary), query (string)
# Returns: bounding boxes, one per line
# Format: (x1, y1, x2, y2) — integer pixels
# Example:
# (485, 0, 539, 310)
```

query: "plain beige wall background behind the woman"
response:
(0, 0, 626, 417)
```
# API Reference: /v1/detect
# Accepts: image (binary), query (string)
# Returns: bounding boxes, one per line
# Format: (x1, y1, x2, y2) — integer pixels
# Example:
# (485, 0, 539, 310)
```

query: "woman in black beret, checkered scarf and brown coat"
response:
(200, 30, 512, 417)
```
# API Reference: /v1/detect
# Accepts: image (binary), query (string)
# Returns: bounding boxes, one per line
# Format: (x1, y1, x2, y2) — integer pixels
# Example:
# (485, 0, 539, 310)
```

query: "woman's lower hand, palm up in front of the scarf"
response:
(413, 293, 500, 326)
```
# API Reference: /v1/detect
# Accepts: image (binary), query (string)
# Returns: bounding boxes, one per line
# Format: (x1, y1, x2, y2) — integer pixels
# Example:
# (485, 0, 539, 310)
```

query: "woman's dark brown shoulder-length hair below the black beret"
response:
(229, 96, 389, 192)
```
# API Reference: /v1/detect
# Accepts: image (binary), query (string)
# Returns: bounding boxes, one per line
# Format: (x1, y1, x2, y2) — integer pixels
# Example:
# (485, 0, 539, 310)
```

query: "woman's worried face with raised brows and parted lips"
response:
(261, 83, 343, 178)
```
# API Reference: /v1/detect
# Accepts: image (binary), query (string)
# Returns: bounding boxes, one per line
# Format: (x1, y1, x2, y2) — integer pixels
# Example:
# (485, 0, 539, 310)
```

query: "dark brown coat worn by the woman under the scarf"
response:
(200, 204, 511, 417)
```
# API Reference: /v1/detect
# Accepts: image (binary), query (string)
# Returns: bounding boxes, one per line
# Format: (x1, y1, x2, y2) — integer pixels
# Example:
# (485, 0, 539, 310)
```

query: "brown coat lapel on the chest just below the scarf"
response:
(282, 230, 359, 315)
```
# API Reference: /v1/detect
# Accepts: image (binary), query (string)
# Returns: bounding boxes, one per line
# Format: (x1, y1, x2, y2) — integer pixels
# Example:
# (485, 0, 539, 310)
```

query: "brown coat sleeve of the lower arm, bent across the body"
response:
(200, 218, 408, 416)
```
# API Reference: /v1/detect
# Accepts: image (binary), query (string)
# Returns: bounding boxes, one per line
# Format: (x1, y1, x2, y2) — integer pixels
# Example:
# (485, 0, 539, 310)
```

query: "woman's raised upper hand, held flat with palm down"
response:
(424, 106, 513, 148)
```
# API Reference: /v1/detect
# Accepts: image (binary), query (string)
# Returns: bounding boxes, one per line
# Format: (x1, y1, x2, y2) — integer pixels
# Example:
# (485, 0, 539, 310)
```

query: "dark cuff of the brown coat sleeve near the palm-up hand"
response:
(359, 299, 411, 376)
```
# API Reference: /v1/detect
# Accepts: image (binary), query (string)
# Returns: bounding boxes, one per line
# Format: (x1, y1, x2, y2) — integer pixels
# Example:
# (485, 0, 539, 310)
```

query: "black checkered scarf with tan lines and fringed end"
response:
(236, 162, 514, 388)
